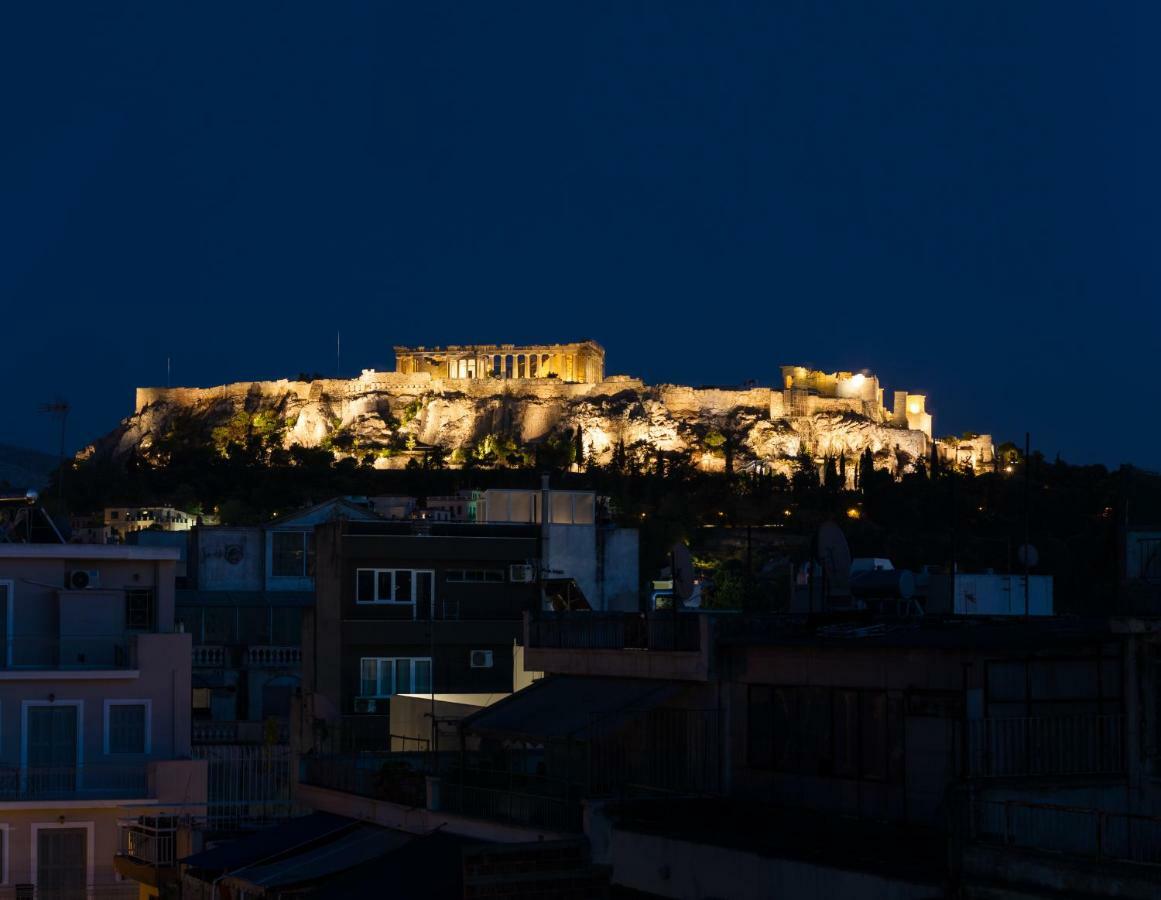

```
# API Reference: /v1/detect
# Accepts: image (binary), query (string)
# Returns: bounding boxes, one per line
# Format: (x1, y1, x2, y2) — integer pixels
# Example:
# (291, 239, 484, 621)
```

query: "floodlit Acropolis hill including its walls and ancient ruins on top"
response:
(95, 340, 993, 473)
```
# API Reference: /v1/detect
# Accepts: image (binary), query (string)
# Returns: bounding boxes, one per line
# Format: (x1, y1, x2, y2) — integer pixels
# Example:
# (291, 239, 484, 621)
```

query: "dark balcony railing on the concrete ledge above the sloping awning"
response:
(528, 612, 701, 651)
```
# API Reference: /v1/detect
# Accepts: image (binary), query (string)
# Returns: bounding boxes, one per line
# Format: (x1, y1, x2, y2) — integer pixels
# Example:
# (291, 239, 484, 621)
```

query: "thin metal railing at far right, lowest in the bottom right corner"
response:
(971, 800, 1161, 865)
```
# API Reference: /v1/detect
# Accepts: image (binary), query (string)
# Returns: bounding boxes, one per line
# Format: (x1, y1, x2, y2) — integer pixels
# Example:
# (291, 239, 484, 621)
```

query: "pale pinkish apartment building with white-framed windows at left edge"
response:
(0, 543, 205, 899)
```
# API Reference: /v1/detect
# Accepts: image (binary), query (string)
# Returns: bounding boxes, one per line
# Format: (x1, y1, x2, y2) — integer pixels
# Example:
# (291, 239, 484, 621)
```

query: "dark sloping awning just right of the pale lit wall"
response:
(463, 675, 680, 742)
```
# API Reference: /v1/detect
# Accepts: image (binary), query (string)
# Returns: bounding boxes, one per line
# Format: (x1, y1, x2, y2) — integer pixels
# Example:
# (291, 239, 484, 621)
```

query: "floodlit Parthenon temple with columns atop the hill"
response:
(395, 340, 605, 384)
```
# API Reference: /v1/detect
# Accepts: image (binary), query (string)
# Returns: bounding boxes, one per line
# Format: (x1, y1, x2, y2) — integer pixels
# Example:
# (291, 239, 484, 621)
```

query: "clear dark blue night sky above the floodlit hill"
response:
(0, 7, 1161, 468)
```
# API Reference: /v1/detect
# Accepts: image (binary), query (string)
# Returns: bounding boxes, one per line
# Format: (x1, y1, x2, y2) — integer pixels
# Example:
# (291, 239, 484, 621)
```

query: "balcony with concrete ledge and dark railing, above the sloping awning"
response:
(524, 612, 712, 681)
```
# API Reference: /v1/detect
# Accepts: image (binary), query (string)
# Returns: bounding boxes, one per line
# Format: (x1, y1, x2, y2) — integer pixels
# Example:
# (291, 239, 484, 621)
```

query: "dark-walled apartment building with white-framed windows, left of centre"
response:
(303, 491, 637, 747)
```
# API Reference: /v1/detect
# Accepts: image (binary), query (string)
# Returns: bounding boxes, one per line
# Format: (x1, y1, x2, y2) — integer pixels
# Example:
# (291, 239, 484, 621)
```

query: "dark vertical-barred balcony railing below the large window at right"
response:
(967, 715, 1125, 778)
